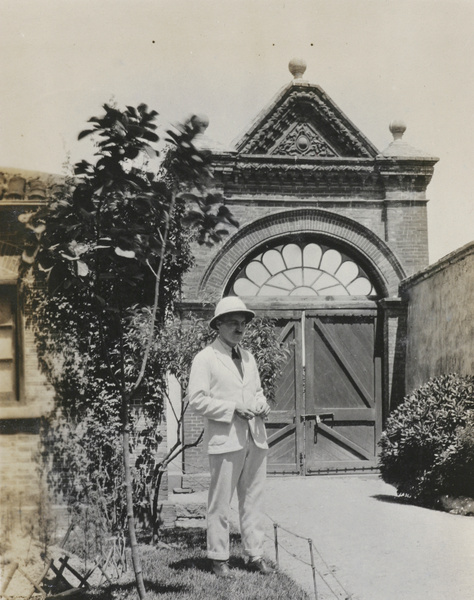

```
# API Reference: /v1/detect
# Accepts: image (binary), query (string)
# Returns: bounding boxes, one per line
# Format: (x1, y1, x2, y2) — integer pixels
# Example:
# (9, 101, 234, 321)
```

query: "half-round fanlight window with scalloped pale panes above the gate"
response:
(232, 242, 376, 297)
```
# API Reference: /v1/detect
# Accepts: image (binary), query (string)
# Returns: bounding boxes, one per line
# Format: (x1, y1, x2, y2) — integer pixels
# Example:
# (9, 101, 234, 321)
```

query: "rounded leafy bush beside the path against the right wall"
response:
(380, 374, 474, 506)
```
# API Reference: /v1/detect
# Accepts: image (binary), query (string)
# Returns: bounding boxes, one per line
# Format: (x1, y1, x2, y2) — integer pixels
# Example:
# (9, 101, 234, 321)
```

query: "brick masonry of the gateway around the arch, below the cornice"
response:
(179, 194, 428, 482)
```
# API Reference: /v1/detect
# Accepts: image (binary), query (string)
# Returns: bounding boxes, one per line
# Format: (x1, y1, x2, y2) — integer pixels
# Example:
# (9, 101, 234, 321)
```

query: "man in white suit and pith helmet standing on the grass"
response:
(189, 296, 272, 578)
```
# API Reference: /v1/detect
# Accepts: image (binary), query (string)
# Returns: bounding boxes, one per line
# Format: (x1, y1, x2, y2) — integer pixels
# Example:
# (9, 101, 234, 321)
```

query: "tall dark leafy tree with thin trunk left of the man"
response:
(20, 104, 238, 599)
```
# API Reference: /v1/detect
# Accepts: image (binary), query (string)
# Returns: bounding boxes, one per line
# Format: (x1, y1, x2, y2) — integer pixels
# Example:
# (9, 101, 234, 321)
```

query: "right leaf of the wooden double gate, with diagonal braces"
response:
(304, 312, 381, 473)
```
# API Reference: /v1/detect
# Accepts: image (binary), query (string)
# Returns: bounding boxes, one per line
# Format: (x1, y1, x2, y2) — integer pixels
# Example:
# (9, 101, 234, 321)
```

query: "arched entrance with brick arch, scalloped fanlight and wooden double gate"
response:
(195, 208, 404, 473)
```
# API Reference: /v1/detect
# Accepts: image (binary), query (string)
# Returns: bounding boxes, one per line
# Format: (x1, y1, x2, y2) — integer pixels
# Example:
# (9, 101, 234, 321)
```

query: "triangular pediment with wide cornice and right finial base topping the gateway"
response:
(214, 78, 437, 200)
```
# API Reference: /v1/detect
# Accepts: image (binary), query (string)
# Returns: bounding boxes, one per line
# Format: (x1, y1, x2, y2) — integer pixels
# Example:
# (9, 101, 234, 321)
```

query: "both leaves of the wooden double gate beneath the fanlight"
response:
(267, 305, 383, 475)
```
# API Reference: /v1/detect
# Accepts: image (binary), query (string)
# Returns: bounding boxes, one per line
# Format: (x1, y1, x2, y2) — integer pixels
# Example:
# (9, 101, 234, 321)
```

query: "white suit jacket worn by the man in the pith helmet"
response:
(188, 339, 268, 454)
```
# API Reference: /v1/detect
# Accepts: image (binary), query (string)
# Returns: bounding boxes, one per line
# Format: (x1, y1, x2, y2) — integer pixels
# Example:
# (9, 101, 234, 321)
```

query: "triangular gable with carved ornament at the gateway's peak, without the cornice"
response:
(236, 83, 378, 158)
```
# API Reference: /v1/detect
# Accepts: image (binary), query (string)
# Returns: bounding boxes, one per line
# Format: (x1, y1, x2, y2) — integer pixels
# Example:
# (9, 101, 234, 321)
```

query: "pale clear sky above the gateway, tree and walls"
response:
(0, 0, 474, 262)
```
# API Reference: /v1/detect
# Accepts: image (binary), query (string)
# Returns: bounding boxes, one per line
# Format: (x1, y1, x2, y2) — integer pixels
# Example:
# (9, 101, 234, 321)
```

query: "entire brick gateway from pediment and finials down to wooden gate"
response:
(183, 59, 436, 474)
